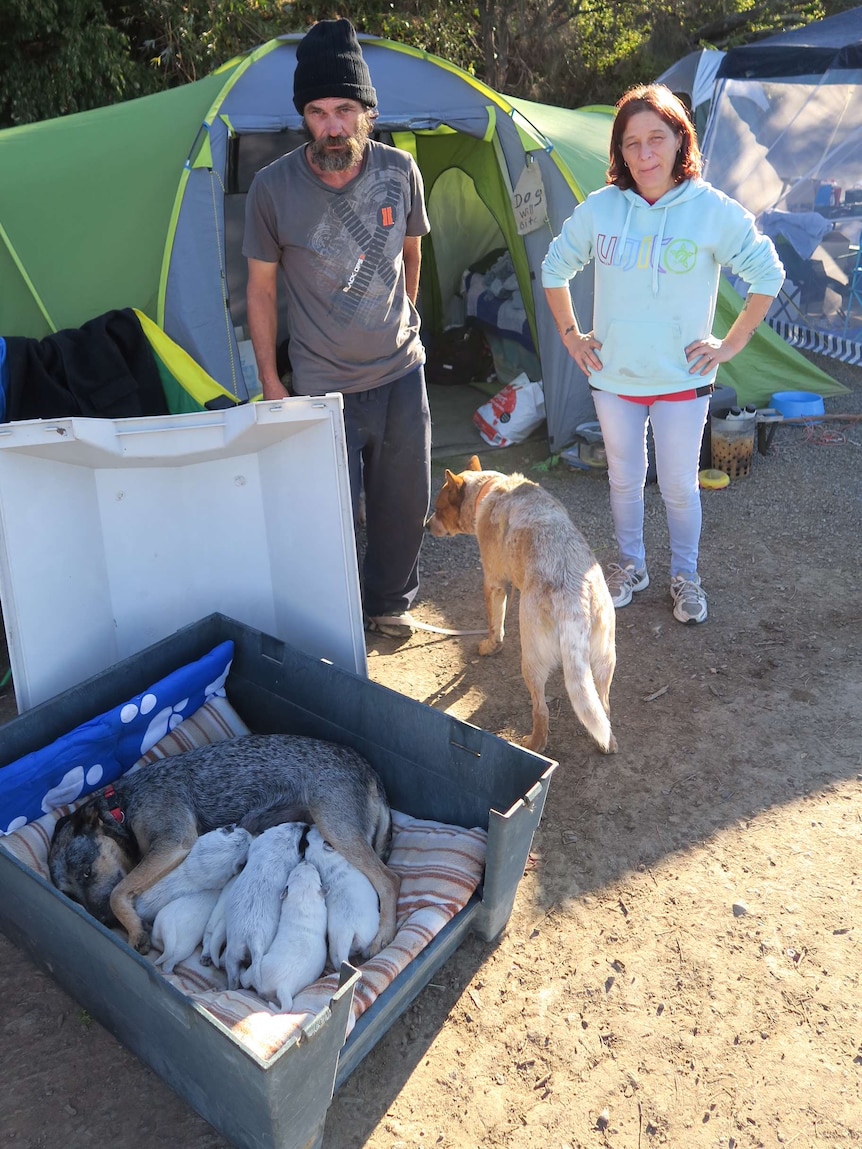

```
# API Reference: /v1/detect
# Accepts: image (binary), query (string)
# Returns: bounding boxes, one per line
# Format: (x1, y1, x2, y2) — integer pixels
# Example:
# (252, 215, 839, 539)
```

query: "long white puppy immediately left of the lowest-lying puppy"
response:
(224, 822, 306, 989)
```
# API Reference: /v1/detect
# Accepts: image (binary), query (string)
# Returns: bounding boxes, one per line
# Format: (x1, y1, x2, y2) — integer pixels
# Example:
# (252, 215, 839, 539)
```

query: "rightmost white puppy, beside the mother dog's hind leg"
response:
(306, 826, 380, 970)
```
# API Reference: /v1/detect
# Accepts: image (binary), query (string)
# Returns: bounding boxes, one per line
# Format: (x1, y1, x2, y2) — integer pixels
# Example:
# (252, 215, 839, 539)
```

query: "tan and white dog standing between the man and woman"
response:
(428, 455, 617, 754)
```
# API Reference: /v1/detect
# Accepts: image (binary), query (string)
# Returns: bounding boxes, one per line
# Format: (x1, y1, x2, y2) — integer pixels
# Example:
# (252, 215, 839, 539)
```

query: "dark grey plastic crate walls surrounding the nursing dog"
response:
(0, 615, 556, 1149)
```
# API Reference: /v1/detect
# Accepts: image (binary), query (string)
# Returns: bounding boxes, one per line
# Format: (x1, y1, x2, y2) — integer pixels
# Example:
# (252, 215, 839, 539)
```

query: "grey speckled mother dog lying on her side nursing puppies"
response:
(48, 734, 400, 954)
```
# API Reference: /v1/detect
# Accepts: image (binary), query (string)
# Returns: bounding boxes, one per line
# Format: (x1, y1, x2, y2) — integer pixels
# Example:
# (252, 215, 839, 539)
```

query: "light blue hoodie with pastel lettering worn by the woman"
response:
(541, 179, 784, 395)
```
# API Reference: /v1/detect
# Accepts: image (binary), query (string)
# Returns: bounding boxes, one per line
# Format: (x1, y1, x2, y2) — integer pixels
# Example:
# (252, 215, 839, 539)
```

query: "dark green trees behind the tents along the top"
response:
(0, 0, 859, 126)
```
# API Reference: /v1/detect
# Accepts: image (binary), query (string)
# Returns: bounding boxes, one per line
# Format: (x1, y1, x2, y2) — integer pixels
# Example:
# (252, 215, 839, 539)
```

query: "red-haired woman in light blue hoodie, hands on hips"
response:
(549, 84, 784, 624)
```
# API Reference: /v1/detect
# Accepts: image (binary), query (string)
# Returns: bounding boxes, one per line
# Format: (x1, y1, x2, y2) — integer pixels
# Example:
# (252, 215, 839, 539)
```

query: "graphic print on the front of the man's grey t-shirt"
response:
(311, 171, 408, 329)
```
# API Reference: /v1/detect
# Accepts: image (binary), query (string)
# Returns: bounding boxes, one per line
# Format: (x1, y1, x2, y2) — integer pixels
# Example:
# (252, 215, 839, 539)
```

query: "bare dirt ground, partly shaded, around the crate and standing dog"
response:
(0, 353, 862, 1149)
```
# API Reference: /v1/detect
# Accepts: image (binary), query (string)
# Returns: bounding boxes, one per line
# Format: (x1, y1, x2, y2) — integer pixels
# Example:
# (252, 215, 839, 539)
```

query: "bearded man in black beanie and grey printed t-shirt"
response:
(243, 20, 431, 638)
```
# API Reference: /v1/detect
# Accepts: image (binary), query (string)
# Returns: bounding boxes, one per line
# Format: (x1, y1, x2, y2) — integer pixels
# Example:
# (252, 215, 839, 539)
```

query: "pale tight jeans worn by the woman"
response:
(593, 391, 709, 578)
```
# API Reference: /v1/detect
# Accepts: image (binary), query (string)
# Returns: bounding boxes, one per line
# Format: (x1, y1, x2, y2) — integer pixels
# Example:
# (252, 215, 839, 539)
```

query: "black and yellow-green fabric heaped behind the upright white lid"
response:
(0, 308, 238, 423)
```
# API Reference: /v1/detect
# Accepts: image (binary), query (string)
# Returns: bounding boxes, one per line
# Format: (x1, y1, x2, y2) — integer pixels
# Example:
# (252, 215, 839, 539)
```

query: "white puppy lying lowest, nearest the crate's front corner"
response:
(255, 862, 326, 1013)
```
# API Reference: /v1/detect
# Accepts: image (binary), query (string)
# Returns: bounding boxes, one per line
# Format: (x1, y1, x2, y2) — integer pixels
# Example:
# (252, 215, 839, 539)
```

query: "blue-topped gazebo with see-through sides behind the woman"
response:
(703, 8, 862, 363)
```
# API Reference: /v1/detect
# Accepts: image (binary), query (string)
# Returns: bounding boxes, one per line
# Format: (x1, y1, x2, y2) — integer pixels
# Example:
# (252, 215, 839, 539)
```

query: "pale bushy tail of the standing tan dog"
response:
(560, 595, 617, 754)
